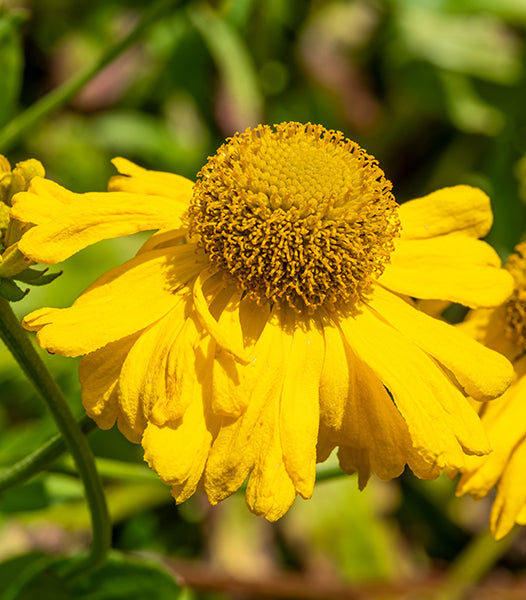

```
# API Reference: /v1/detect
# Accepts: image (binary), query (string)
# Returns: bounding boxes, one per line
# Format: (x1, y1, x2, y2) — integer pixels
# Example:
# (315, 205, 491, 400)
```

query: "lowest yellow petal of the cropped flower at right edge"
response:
(490, 440, 526, 540)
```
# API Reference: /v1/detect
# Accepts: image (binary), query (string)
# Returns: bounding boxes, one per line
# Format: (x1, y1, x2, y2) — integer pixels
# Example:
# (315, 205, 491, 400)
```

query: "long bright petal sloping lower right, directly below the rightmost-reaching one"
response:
(340, 305, 488, 468)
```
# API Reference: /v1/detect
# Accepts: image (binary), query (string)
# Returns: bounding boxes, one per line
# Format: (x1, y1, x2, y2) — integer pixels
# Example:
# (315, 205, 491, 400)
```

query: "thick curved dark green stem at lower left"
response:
(0, 298, 111, 576)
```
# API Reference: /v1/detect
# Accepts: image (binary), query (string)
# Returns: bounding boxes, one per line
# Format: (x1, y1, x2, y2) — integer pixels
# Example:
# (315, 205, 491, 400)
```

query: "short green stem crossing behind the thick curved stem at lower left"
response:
(0, 416, 96, 493)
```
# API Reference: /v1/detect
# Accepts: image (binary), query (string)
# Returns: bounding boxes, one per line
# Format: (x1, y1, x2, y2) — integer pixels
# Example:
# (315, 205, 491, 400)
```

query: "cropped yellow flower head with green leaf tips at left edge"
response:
(0, 155, 57, 301)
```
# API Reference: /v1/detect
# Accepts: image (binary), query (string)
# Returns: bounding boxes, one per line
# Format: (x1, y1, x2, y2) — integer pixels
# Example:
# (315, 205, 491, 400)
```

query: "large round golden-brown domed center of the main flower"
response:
(189, 123, 400, 313)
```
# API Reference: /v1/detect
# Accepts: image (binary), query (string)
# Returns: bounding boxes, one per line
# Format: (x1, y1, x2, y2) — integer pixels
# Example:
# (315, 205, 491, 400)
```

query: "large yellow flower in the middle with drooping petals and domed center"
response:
(14, 123, 512, 520)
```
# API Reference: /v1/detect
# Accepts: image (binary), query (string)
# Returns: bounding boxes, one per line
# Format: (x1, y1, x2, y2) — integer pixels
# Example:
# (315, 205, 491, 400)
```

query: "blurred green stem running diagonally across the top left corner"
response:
(0, 0, 186, 153)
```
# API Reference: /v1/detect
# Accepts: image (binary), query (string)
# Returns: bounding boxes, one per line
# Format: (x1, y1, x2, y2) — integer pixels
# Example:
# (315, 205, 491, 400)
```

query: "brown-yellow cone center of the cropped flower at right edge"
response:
(504, 242, 526, 351)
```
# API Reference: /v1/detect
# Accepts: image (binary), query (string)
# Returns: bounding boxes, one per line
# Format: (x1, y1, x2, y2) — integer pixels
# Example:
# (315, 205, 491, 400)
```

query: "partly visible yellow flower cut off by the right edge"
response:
(457, 243, 526, 539)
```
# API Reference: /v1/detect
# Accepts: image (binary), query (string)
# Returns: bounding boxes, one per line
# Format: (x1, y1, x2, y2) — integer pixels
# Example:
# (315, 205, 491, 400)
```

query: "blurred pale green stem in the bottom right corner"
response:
(435, 527, 520, 600)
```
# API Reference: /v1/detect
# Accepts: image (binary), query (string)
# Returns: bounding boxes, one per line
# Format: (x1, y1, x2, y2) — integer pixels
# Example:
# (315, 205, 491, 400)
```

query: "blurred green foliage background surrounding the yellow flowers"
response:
(0, 0, 526, 600)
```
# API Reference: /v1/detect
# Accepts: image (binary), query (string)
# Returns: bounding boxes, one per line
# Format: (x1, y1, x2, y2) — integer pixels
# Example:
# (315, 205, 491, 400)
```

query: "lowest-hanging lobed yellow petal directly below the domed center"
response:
(205, 314, 310, 521)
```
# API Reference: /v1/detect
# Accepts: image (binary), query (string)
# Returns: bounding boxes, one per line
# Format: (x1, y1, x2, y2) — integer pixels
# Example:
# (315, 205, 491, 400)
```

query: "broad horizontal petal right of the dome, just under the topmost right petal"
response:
(378, 234, 513, 307)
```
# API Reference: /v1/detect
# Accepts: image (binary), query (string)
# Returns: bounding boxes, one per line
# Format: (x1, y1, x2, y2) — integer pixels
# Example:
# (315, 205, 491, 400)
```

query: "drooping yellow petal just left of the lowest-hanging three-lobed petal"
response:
(142, 338, 220, 503)
